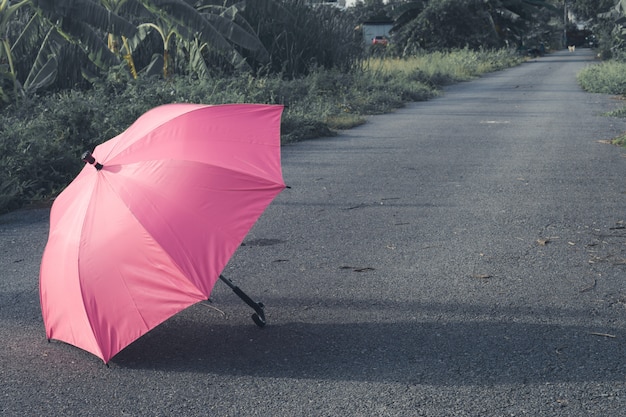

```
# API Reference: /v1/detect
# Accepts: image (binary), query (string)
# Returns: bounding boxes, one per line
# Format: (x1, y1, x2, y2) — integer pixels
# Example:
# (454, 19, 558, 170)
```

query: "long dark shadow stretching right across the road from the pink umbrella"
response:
(111, 300, 626, 385)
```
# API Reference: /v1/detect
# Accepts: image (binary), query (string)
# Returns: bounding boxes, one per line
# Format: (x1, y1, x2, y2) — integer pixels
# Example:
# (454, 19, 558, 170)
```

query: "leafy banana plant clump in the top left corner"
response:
(0, 0, 136, 105)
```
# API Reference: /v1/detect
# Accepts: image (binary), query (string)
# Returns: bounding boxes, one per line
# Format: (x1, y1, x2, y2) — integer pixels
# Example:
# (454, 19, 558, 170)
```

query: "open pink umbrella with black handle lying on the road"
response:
(40, 104, 285, 363)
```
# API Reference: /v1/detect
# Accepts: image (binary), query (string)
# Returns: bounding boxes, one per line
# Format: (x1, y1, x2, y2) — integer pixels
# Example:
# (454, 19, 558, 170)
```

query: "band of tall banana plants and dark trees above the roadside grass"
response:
(0, 0, 582, 106)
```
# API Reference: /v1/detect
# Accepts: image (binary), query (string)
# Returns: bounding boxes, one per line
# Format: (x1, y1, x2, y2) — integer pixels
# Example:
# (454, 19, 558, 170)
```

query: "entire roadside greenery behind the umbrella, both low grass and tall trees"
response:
(0, 0, 626, 213)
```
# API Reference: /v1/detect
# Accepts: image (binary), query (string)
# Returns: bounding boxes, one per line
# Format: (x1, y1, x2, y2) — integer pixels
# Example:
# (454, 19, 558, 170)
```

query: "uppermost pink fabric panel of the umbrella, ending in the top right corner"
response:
(94, 104, 282, 182)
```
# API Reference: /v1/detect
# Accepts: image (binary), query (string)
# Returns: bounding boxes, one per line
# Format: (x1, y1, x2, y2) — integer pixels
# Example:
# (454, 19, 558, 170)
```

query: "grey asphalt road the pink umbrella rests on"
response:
(0, 50, 626, 417)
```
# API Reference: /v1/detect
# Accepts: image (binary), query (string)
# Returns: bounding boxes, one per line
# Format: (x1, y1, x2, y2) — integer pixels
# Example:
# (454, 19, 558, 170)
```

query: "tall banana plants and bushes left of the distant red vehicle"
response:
(0, 0, 370, 106)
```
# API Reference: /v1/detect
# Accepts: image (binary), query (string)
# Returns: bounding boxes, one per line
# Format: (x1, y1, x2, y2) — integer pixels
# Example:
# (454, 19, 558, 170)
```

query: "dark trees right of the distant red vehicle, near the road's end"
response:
(389, 0, 562, 56)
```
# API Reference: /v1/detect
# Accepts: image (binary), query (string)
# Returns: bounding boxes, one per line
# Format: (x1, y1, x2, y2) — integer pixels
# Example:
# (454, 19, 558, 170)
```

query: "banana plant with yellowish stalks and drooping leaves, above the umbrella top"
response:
(120, 0, 267, 77)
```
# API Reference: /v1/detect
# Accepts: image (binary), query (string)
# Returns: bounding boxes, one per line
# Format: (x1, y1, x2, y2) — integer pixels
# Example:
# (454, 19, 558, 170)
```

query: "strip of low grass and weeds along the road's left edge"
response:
(0, 50, 520, 213)
